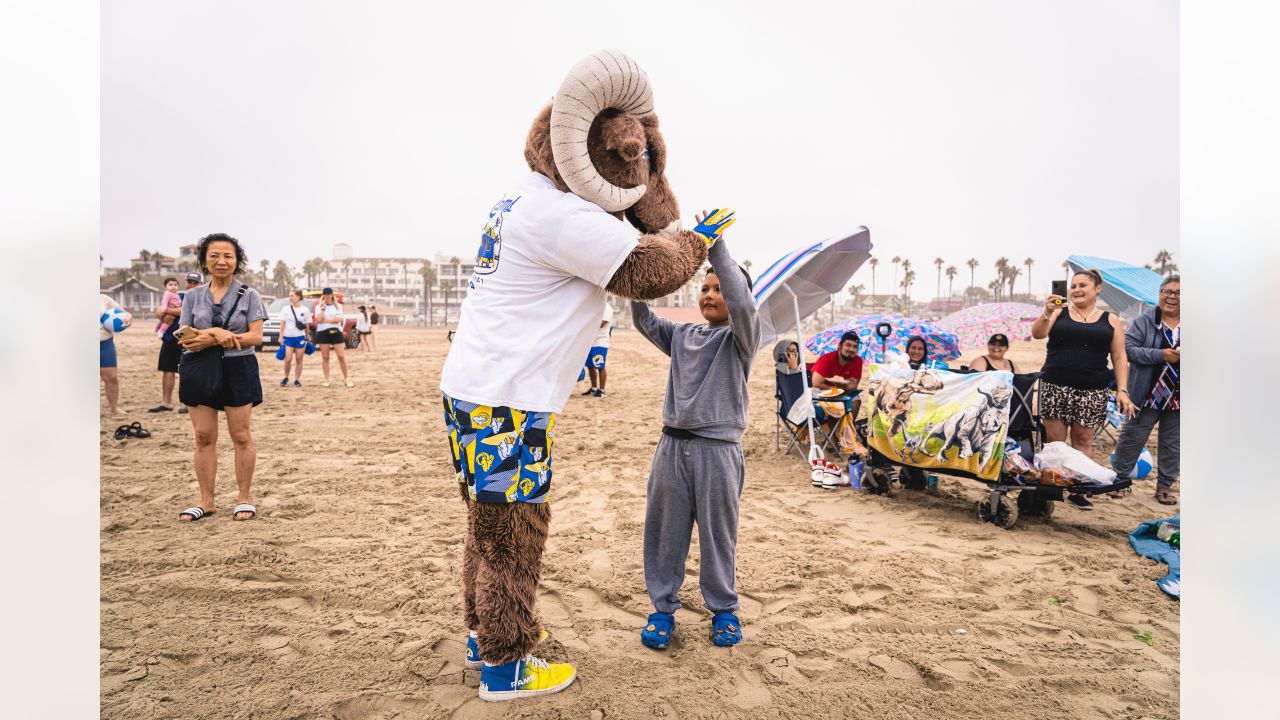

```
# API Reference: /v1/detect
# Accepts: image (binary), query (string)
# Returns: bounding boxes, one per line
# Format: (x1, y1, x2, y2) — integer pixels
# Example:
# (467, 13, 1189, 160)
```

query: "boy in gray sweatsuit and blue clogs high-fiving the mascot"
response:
(631, 218, 760, 650)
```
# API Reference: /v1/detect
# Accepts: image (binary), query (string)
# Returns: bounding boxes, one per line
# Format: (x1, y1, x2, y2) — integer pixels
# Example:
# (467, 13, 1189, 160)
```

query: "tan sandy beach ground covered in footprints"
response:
(99, 323, 1180, 720)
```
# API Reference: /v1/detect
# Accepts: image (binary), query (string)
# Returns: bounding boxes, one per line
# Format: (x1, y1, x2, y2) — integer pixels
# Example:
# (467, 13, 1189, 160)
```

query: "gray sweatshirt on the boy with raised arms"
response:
(631, 242, 760, 442)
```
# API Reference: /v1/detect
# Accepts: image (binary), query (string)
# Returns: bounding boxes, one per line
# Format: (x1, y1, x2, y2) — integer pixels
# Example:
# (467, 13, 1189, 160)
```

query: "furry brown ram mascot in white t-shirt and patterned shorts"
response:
(440, 50, 732, 701)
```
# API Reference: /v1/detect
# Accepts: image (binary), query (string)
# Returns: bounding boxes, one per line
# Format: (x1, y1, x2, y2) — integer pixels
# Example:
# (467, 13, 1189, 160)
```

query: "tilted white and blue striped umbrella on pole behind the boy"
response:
(751, 227, 872, 459)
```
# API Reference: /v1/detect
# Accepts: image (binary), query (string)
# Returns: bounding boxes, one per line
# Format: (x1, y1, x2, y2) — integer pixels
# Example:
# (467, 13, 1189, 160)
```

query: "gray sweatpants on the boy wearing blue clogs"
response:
(644, 434, 746, 612)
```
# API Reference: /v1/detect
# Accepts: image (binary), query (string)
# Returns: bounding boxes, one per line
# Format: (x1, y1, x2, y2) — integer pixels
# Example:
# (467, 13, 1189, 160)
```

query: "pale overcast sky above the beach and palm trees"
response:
(101, 0, 1179, 299)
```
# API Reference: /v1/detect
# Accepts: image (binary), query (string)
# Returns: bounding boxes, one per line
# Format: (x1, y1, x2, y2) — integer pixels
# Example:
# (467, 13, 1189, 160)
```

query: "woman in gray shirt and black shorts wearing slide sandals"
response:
(174, 233, 266, 523)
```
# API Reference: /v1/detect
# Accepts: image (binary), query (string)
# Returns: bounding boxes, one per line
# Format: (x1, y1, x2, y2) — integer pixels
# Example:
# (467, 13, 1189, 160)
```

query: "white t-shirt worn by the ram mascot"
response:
(440, 173, 640, 413)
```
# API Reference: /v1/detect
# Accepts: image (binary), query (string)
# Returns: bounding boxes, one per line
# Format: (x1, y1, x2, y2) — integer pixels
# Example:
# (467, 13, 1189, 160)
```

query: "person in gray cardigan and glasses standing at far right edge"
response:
(1111, 275, 1181, 505)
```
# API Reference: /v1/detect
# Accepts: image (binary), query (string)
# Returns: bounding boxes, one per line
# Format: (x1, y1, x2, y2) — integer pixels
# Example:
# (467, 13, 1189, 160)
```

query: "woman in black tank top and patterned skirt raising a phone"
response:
(1032, 270, 1134, 510)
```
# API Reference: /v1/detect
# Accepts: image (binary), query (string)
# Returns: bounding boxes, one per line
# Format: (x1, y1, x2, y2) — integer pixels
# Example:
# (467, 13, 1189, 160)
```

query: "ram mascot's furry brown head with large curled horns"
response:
(525, 50, 680, 234)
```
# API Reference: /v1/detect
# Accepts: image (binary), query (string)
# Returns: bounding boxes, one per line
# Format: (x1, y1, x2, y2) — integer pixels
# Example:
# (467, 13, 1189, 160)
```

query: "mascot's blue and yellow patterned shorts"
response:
(444, 395, 556, 502)
